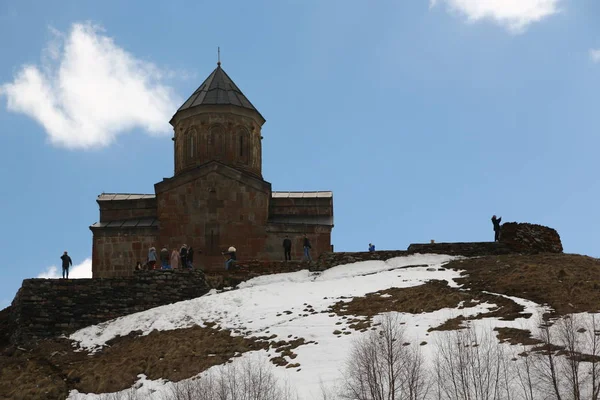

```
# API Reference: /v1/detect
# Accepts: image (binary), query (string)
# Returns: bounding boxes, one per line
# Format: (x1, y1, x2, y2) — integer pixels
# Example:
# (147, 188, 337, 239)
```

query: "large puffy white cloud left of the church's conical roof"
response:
(0, 24, 180, 149)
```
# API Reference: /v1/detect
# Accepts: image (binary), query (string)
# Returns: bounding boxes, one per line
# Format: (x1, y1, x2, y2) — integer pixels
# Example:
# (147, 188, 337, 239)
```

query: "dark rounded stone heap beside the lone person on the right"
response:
(500, 222, 563, 254)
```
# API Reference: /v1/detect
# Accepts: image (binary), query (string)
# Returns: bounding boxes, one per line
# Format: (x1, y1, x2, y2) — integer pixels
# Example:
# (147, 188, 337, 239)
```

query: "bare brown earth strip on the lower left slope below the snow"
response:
(0, 327, 310, 400)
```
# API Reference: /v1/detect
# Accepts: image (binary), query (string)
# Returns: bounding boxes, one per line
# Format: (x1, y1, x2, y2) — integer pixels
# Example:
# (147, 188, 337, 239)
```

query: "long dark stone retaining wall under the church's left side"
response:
(11, 270, 209, 343)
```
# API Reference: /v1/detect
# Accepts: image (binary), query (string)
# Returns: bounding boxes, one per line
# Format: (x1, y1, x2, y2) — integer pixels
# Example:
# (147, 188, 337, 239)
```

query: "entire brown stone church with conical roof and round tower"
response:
(90, 63, 333, 278)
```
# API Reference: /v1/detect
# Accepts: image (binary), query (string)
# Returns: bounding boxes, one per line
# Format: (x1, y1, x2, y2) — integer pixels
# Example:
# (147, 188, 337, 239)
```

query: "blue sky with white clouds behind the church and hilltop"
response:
(0, 0, 600, 307)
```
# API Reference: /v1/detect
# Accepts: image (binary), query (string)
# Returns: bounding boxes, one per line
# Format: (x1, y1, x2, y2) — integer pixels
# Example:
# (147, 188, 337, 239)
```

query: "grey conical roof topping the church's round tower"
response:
(177, 62, 264, 120)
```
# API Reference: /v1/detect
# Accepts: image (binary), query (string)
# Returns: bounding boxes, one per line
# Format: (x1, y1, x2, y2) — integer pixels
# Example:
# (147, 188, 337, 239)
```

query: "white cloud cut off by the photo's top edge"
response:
(429, 0, 561, 33)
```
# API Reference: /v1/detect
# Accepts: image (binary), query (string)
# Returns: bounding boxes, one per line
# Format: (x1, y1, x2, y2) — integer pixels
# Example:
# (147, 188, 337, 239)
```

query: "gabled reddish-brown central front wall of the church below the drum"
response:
(155, 163, 271, 269)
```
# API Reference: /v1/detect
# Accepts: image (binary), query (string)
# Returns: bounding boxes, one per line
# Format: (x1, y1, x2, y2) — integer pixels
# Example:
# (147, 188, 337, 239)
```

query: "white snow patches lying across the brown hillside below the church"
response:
(69, 254, 547, 400)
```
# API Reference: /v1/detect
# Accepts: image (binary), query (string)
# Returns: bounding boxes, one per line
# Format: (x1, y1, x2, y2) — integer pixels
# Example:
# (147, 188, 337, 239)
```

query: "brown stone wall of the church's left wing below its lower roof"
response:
(92, 227, 160, 278)
